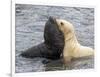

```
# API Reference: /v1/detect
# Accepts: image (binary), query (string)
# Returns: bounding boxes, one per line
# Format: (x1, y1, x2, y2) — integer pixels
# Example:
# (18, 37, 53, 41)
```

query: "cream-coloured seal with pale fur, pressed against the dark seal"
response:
(56, 19, 94, 64)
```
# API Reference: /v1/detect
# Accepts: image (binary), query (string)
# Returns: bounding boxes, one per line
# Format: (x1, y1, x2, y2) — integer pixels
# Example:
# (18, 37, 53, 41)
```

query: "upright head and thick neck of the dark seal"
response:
(44, 16, 64, 53)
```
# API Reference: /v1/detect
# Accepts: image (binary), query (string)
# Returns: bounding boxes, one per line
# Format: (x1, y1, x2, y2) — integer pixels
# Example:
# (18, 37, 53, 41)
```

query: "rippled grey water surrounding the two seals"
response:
(15, 4, 94, 73)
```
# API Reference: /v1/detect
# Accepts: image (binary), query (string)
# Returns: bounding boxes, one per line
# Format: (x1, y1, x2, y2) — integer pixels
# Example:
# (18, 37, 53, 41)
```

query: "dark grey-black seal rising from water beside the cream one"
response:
(21, 17, 64, 60)
